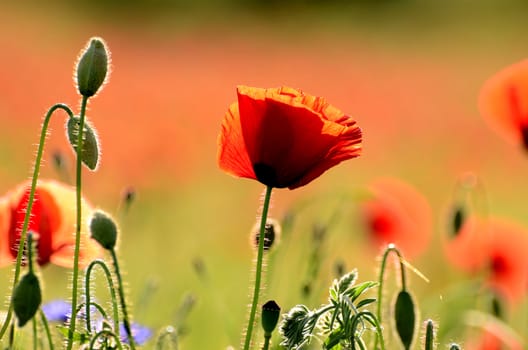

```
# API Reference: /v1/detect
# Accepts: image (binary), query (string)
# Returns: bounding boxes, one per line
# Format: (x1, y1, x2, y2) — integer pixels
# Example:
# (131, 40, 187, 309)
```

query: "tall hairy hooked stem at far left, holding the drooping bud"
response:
(0, 103, 73, 340)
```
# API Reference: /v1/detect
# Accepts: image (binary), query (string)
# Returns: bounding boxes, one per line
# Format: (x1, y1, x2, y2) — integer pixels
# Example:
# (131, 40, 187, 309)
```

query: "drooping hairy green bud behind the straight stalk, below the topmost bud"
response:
(66, 117, 99, 171)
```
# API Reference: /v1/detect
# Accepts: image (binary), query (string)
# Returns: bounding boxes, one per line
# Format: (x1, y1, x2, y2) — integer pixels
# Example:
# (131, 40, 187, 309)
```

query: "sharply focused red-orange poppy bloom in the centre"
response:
(218, 86, 361, 189)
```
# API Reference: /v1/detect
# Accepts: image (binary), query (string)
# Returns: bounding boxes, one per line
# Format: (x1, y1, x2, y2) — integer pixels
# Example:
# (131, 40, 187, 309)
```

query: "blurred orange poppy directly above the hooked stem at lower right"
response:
(359, 178, 432, 257)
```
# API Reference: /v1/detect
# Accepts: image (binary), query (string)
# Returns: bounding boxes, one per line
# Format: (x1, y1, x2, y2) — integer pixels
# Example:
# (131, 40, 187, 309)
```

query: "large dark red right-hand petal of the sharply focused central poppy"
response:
(238, 86, 361, 189)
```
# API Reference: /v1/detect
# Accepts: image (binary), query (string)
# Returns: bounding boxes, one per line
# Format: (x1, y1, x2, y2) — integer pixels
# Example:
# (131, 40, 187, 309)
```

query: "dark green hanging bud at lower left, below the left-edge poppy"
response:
(13, 272, 42, 327)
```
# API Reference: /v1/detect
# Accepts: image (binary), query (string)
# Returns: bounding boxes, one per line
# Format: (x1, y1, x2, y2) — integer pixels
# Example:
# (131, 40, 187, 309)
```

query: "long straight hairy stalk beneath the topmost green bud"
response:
(67, 96, 88, 350)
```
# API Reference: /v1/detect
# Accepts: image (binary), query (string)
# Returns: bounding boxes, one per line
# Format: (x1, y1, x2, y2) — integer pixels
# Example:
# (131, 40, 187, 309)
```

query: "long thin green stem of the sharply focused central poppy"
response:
(244, 186, 273, 350)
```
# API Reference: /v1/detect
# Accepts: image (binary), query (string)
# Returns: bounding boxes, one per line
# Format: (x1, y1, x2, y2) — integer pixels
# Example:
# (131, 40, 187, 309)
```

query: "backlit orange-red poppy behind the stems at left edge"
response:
(0, 180, 102, 267)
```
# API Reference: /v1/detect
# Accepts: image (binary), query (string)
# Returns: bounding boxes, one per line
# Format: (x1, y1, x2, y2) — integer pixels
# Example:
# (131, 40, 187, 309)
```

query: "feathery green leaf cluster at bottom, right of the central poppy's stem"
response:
(279, 270, 381, 349)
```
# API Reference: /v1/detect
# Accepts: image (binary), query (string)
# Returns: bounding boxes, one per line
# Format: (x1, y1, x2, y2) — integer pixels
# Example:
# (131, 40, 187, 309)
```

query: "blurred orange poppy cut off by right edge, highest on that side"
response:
(478, 60, 528, 150)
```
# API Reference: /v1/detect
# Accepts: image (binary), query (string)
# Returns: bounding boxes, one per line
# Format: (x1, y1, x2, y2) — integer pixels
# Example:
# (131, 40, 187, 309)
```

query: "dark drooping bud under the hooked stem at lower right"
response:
(394, 290, 416, 350)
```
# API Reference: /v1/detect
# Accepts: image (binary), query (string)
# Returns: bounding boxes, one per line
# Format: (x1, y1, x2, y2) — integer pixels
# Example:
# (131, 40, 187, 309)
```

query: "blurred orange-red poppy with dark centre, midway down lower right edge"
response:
(444, 217, 528, 302)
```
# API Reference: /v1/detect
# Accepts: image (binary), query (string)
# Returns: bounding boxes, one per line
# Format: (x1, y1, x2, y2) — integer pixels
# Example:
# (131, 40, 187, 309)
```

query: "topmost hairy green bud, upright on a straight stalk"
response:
(76, 38, 109, 97)
